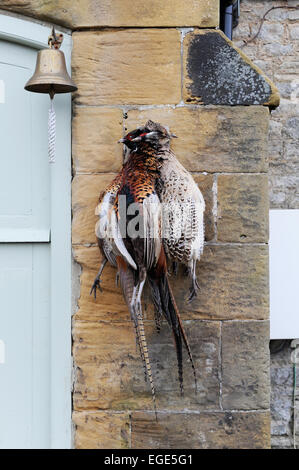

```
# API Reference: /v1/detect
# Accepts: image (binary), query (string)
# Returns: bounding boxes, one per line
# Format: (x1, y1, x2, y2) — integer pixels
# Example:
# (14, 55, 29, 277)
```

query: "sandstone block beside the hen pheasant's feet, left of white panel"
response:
(171, 245, 269, 320)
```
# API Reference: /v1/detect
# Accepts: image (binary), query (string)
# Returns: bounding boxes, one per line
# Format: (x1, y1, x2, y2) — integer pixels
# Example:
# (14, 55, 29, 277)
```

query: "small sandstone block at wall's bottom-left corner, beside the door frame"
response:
(73, 411, 130, 449)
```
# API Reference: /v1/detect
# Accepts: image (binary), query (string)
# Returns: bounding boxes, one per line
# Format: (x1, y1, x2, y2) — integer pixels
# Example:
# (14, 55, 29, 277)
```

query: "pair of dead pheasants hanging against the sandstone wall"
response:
(91, 121, 205, 412)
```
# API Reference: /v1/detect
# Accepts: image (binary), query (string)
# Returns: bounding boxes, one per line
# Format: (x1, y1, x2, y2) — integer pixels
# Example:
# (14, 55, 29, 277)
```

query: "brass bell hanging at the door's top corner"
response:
(25, 28, 78, 98)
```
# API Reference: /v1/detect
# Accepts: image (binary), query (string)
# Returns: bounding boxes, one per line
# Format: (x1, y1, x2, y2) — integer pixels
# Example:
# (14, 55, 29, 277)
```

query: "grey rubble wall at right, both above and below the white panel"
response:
(233, 0, 299, 448)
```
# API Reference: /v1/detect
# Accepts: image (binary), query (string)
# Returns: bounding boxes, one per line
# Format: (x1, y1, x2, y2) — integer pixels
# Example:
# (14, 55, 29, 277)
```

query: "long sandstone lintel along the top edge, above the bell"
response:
(1, 0, 219, 28)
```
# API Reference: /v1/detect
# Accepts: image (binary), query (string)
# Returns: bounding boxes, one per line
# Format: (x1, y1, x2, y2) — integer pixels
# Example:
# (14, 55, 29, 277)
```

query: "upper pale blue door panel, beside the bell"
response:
(0, 40, 50, 235)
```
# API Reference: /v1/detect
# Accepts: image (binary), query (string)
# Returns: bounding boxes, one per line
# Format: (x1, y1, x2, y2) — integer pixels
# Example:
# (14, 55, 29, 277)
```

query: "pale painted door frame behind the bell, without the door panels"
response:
(0, 10, 72, 449)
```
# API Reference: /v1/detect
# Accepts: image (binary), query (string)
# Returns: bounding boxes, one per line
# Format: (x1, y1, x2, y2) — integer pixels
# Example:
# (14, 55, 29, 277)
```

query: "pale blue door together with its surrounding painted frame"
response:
(0, 15, 71, 448)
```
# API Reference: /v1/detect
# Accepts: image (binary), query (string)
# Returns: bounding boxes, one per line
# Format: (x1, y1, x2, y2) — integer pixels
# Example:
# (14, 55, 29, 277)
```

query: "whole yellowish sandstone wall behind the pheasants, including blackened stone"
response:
(2, 0, 279, 448)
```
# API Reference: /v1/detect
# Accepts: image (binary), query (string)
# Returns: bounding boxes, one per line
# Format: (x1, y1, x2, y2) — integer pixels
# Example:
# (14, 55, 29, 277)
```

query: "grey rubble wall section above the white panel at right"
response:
(233, 0, 299, 209)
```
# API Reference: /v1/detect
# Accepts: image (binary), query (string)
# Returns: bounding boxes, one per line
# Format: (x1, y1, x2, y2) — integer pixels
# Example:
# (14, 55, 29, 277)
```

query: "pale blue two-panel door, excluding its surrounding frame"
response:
(0, 36, 50, 448)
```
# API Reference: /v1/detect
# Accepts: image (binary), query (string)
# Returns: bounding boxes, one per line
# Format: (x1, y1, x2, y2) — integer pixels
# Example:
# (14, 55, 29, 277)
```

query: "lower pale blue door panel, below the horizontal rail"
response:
(0, 243, 50, 448)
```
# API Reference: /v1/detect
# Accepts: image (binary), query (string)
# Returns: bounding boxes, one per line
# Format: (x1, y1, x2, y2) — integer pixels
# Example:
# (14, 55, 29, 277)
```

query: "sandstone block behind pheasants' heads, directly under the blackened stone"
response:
(125, 106, 269, 172)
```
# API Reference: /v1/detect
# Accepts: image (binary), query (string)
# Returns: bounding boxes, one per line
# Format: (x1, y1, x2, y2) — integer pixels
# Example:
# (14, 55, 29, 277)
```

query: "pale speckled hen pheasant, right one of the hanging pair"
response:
(122, 121, 205, 300)
